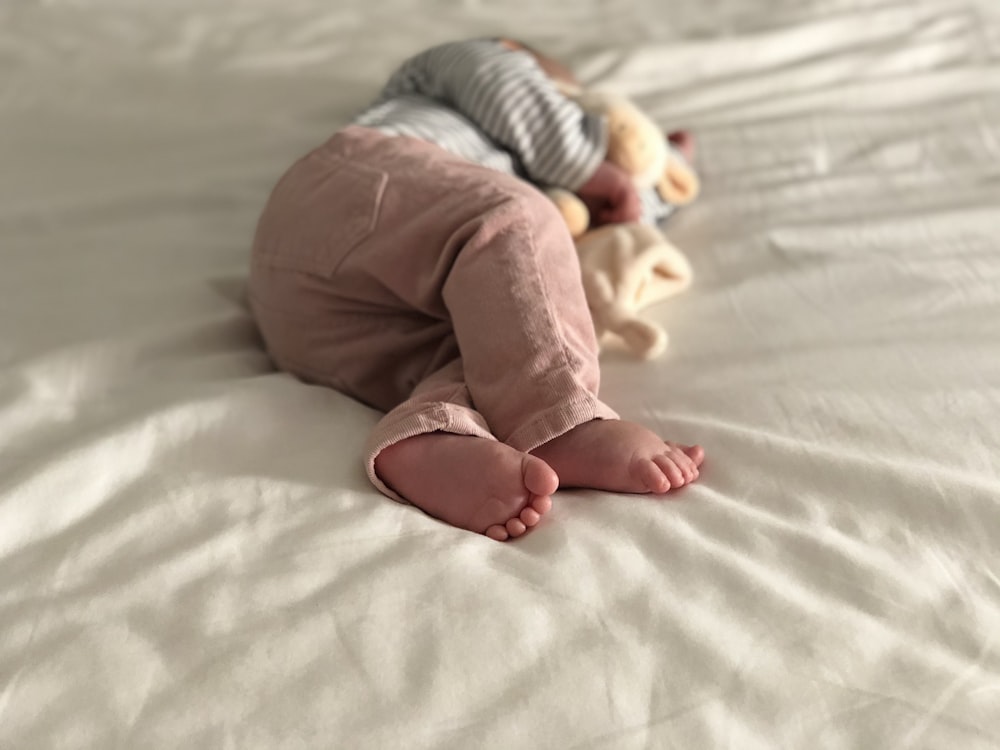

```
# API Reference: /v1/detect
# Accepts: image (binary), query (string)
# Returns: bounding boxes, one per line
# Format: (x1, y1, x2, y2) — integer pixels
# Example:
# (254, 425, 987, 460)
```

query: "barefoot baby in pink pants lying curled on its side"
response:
(250, 39, 704, 541)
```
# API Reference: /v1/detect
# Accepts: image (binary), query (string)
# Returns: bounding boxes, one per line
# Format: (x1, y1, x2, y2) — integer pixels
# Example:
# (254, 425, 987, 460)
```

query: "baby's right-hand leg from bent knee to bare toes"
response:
(434, 160, 704, 494)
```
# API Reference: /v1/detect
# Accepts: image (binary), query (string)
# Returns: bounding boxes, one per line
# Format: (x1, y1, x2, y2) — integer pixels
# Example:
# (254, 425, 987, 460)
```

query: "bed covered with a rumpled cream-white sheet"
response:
(0, 0, 1000, 750)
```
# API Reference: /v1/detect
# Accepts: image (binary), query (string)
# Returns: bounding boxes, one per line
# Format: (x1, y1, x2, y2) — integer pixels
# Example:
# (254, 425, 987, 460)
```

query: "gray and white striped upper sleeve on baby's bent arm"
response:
(382, 39, 607, 190)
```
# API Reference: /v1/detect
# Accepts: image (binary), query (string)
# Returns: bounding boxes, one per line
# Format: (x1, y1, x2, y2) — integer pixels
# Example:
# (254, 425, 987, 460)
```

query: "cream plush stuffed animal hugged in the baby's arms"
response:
(549, 92, 699, 359)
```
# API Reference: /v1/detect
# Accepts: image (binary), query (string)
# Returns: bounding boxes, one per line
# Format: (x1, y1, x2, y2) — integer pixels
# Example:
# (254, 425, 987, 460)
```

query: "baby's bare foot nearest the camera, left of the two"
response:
(375, 432, 559, 541)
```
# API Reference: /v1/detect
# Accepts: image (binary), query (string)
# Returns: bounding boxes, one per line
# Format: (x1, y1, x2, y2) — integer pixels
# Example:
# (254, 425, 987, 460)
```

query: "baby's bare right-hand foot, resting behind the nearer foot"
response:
(531, 419, 705, 495)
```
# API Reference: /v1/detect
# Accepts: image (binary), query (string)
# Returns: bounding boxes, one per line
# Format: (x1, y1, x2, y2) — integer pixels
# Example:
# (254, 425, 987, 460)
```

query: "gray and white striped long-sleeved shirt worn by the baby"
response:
(354, 39, 669, 223)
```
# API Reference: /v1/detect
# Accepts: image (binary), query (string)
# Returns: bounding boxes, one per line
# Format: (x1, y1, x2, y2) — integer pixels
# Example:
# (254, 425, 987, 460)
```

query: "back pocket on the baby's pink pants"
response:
(254, 152, 388, 277)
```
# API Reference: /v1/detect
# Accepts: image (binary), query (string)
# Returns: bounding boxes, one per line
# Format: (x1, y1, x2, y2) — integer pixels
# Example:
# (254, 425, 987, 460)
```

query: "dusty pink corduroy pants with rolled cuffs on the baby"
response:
(250, 127, 616, 499)
